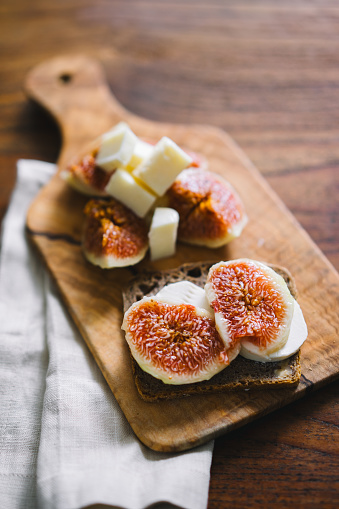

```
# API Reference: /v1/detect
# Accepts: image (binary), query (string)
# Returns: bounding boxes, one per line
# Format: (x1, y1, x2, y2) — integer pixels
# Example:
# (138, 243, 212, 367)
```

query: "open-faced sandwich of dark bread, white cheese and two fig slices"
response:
(122, 259, 307, 401)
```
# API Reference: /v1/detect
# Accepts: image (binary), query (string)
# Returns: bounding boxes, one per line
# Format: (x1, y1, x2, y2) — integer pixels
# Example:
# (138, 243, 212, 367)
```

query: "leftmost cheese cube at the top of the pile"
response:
(96, 122, 138, 171)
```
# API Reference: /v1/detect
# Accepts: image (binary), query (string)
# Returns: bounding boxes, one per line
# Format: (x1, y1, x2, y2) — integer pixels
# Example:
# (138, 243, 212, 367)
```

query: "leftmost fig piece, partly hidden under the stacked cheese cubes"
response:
(61, 148, 114, 196)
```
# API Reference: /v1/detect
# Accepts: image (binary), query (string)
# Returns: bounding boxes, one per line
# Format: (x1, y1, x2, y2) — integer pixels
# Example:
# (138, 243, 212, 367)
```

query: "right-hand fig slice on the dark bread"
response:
(205, 258, 294, 356)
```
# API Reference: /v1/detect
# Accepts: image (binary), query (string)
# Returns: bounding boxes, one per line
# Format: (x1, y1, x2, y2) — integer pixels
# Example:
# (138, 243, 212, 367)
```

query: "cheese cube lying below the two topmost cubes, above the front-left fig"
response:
(105, 168, 156, 217)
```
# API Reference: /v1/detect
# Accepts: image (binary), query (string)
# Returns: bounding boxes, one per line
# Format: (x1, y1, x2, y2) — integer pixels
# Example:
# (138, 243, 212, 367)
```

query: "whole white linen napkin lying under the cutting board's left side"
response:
(0, 160, 213, 509)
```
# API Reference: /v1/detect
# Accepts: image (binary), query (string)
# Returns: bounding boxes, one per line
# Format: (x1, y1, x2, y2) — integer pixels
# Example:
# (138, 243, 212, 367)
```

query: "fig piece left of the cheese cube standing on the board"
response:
(82, 199, 148, 269)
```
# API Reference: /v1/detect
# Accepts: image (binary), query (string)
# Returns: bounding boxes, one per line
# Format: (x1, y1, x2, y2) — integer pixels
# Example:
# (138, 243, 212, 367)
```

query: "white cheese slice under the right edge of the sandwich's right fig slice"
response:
(240, 300, 308, 362)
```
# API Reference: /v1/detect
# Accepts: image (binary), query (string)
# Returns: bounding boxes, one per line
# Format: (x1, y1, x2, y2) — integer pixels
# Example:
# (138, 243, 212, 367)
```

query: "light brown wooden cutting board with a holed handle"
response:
(26, 56, 339, 451)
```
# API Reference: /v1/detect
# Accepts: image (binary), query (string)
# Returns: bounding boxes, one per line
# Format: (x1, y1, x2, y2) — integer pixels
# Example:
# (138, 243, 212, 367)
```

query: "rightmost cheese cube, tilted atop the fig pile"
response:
(133, 136, 192, 196)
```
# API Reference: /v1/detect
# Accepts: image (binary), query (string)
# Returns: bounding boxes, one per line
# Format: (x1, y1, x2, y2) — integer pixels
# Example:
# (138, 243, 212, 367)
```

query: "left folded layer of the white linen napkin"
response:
(0, 161, 54, 509)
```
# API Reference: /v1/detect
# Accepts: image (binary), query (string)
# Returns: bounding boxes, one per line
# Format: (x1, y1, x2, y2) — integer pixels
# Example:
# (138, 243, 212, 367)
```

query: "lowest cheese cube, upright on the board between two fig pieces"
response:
(148, 207, 179, 260)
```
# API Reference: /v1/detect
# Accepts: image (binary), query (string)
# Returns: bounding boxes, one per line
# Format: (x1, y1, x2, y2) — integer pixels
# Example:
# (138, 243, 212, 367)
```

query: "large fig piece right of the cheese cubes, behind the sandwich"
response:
(166, 168, 247, 248)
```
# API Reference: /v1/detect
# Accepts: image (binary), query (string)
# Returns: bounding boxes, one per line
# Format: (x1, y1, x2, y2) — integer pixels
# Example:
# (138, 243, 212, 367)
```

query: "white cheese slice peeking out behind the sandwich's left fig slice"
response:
(153, 281, 214, 317)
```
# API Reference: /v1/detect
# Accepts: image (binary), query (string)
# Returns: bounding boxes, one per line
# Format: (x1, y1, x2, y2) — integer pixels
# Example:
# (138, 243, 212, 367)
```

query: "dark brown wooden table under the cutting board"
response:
(0, 0, 339, 509)
